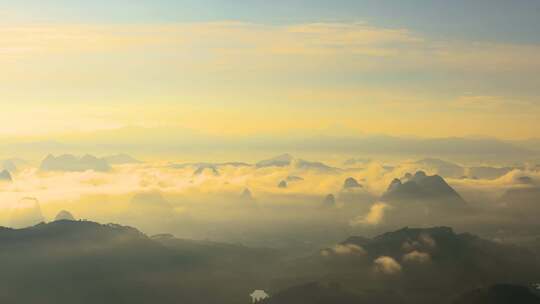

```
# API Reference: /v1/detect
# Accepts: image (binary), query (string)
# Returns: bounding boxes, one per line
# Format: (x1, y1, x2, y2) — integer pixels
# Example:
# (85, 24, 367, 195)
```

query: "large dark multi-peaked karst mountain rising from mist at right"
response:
(381, 171, 465, 205)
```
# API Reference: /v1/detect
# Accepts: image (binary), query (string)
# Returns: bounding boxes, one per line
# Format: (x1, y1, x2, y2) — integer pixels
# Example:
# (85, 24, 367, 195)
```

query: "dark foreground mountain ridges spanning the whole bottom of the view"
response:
(0, 220, 539, 304)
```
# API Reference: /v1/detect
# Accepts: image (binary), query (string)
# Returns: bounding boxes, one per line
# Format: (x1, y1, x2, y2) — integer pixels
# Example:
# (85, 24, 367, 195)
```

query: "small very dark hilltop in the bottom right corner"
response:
(452, 284, 540, 304)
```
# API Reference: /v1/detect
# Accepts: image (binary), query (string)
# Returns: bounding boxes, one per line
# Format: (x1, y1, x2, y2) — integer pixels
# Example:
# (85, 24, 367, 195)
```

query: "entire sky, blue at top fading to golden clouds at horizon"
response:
(0, 0, 540, 139)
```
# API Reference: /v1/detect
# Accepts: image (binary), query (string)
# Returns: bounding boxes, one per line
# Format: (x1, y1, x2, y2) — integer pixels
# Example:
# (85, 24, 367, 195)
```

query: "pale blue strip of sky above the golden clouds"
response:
(6, 0, 540, 43)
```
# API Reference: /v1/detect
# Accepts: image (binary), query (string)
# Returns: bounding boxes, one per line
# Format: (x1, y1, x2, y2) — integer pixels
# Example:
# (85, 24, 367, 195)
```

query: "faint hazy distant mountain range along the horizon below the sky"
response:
(1, 132, 540, 159)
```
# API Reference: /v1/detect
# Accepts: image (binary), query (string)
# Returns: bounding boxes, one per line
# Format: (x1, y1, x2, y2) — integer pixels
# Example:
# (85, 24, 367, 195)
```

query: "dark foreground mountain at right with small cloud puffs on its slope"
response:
(292, 227, 540, 304)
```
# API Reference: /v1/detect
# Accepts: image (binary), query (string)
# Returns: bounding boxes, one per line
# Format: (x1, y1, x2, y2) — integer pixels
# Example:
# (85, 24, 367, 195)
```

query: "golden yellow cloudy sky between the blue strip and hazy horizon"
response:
(0, 14, 540, 139)
